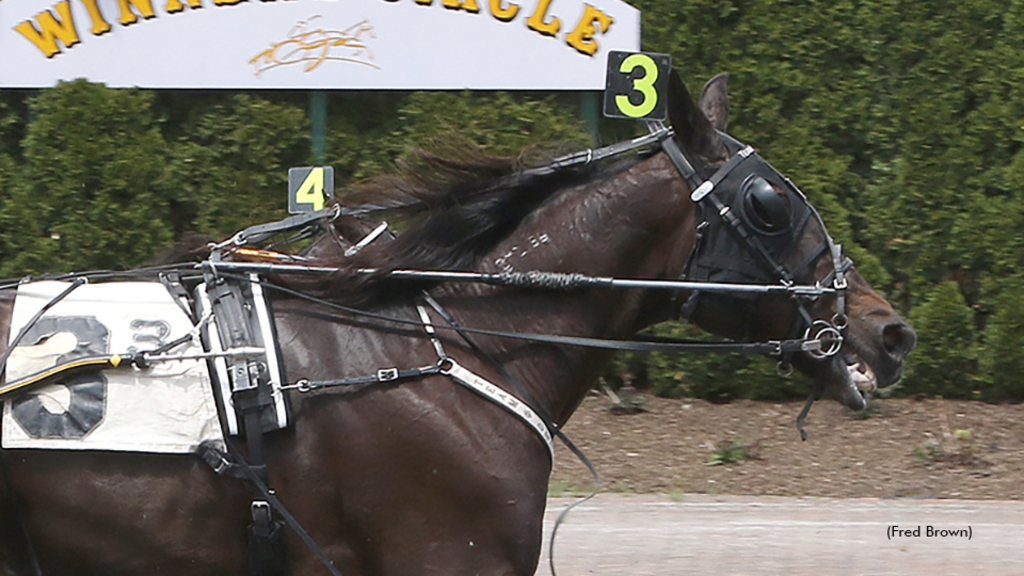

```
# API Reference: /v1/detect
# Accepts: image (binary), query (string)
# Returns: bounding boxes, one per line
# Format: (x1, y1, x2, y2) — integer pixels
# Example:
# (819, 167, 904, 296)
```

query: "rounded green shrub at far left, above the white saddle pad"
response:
(0, 80, 172, 277)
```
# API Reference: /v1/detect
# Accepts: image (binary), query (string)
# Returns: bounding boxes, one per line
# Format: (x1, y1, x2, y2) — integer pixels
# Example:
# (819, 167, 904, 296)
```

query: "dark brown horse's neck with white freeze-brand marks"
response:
(442, 155, 694, 423)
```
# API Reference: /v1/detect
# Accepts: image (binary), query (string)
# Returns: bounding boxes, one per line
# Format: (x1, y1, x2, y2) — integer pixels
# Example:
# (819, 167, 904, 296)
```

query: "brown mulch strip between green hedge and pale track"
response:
(551, 389, 1024, 498)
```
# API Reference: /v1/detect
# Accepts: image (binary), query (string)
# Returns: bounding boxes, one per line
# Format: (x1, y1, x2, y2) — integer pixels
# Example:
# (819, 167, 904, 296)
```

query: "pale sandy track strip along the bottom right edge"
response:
(537, 494, 1024, 576)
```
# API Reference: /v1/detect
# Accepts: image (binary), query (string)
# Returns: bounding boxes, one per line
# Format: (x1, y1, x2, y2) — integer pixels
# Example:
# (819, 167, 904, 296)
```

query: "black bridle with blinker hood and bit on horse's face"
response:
(647, 122, 853, 372)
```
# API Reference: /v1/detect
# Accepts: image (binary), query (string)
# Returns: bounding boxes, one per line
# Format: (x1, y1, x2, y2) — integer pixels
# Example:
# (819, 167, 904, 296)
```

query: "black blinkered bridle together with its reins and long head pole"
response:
(155, 122, 853, 367)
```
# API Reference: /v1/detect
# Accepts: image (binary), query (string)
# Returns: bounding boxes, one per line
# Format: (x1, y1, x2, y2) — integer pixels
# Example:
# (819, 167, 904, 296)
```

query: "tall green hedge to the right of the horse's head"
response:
(635, 0, 1024, 400)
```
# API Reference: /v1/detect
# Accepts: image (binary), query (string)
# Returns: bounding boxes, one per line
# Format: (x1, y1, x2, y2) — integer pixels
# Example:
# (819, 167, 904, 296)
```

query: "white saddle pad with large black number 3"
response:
(2, 282, 224, 453)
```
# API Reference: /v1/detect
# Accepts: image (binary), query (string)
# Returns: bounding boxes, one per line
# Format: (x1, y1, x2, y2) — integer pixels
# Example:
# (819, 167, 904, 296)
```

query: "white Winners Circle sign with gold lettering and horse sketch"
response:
(0, 0, 640, 90)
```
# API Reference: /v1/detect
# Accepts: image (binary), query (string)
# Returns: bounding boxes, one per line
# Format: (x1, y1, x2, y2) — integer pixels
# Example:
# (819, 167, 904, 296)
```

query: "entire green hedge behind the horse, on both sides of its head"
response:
(0, 0, 1024, 400)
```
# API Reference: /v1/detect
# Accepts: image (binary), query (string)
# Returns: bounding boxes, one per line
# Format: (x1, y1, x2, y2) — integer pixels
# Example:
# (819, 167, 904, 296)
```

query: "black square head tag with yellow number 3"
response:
(604, 51, 672, 120)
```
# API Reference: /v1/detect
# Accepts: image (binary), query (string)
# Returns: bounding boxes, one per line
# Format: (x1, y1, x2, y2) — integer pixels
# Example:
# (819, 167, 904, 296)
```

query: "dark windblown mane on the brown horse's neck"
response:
(296, 145, 610, 303)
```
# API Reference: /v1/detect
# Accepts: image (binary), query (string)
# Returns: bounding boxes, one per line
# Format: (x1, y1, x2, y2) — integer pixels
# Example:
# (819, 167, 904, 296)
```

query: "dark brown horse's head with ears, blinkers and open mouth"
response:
(670, 73, 916, 410)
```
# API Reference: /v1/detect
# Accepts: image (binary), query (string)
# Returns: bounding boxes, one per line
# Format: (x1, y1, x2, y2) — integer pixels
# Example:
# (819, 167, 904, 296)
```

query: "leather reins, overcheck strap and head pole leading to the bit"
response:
(197, 122, 852, 362)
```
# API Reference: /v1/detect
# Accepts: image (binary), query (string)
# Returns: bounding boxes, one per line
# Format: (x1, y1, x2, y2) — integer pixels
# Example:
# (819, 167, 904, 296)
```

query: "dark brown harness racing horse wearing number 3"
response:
(0, 74, 915, 576)
